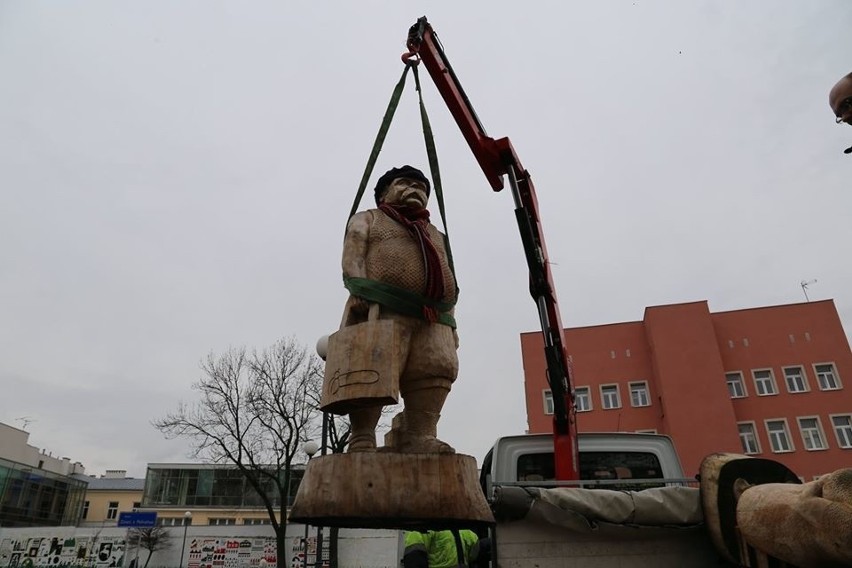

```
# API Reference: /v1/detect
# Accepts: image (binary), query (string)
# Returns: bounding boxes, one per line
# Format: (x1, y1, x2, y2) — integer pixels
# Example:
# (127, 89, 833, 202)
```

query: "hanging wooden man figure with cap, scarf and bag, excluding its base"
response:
(323, 166, 458, 453)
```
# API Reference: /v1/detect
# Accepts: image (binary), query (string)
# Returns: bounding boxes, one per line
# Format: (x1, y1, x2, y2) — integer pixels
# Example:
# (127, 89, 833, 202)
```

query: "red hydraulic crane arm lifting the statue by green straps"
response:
(402, 16, 579, 480)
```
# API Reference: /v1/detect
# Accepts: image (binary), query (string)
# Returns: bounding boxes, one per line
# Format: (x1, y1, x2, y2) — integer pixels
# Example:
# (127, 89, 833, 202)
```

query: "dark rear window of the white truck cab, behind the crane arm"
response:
(518, 452, 663, 481)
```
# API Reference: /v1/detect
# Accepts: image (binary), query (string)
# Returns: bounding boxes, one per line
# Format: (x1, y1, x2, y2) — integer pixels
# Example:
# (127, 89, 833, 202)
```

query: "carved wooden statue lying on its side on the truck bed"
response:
(700, 454, 852, 568)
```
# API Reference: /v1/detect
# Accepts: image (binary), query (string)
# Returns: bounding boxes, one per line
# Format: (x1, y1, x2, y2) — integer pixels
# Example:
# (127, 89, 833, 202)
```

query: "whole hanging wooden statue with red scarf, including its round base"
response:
(290, 166, 494, 530)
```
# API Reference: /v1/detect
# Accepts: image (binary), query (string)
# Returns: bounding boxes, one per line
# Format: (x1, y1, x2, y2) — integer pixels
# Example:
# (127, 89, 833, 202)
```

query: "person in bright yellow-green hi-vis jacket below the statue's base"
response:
(402, 529, 484, 568)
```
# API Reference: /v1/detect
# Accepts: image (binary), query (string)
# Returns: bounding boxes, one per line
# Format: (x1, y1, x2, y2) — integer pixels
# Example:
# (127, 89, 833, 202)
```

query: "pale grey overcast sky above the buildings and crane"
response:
(0, 0, 852, 477)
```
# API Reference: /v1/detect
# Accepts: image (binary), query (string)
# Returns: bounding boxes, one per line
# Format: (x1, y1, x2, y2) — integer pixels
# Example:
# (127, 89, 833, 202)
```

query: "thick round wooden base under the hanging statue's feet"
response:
(290, 452, 494, 530)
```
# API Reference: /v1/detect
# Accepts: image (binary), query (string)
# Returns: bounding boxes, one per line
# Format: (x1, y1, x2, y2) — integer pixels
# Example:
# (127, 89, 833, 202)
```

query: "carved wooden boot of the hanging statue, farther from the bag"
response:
(392, 387, 455, 454)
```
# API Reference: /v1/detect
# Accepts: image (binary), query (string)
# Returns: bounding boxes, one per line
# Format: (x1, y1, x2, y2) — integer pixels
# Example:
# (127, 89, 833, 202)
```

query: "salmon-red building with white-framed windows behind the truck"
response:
(521, 300, 852, 481)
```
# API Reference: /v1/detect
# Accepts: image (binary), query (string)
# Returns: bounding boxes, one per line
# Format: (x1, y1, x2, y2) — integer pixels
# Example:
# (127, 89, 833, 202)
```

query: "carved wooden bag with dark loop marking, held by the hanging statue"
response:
(320, 304, 399, 414)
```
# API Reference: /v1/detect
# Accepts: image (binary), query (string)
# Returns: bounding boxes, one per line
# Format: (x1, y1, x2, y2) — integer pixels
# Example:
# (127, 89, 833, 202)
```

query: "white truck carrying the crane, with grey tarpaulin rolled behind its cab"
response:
(480, 433, 733, 568)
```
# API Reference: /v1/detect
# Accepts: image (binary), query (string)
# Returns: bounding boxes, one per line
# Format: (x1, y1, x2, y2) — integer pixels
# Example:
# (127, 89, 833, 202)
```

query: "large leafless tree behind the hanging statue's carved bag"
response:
(154, 338, 322, 568)
